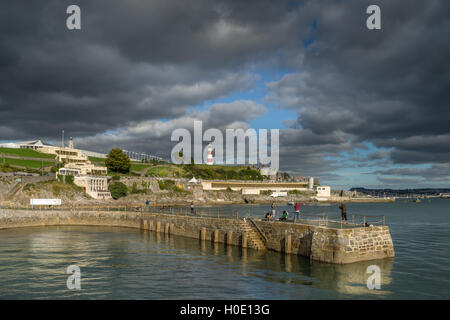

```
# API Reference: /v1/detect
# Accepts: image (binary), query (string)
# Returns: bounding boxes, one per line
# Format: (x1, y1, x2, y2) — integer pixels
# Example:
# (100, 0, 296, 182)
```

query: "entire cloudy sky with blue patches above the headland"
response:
(0, 0, 450, 188)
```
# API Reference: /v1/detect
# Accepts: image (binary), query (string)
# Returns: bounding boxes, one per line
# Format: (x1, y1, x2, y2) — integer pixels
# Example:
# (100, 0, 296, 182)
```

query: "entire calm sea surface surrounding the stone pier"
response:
(0, 199, 450, 299)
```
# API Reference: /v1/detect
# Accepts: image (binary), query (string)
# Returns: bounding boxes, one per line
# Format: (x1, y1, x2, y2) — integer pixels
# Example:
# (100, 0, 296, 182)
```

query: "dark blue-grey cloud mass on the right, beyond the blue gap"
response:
(266, 0, 450, 180)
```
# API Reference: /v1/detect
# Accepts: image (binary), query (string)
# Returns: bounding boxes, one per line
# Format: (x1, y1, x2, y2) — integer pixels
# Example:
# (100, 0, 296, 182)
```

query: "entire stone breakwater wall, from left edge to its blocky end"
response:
(0, 210, 394, 264)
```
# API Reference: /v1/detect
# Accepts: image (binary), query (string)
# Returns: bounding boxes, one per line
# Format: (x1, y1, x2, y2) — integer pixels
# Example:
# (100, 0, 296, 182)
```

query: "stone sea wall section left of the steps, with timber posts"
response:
(0, 209, 256, 249)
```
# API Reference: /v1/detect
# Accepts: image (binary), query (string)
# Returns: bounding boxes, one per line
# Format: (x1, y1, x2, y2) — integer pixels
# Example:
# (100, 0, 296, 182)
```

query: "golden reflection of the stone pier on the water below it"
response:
(142, 228, 394, 297)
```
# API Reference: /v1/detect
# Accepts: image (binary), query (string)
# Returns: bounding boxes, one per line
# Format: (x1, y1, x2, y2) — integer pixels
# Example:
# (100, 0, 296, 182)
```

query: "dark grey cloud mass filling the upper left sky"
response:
(0, 0, 300, 139)
